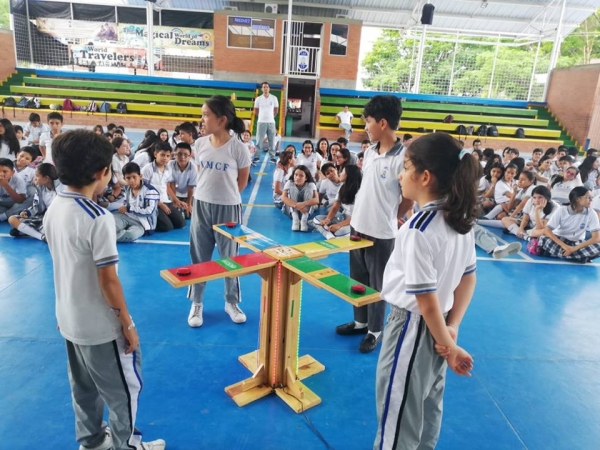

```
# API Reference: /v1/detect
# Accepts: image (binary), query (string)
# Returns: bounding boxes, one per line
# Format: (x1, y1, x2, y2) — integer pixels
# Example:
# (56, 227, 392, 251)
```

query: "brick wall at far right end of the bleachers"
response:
(547, 64, 600, 148)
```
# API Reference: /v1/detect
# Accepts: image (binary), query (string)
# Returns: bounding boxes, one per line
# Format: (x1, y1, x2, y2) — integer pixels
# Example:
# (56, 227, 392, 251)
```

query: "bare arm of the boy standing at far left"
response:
(98, 264, 139, 354)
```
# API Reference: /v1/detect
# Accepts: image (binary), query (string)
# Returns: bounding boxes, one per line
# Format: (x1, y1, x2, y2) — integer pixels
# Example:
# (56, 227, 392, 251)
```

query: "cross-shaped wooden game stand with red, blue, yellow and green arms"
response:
(161, 224, 379, 413)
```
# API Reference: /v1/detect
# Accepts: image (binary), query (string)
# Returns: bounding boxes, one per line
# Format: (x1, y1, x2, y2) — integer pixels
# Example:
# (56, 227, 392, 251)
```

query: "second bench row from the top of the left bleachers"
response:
(10, 85, 254, 108)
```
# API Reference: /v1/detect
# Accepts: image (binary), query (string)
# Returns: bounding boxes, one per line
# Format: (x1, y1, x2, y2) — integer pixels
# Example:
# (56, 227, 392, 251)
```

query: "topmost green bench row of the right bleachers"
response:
(321, 96, 536, 117)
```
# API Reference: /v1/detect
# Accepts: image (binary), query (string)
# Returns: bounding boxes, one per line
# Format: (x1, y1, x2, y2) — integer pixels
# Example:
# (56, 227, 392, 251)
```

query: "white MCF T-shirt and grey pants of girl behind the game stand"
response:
(188, 136, 250, 304)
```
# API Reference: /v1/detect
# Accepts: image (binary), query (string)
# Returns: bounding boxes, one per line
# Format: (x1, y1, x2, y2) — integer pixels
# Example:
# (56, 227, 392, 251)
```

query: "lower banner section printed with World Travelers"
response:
(69, 43, 146, 68)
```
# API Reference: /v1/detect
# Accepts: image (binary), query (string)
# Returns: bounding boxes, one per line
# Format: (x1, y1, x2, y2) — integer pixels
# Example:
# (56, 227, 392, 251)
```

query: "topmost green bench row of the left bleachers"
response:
(23, 77, 254, 99)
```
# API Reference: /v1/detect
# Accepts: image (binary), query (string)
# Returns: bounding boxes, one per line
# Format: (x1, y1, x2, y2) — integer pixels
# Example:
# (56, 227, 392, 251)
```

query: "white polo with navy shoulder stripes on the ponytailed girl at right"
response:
(382, 201, 476, 314)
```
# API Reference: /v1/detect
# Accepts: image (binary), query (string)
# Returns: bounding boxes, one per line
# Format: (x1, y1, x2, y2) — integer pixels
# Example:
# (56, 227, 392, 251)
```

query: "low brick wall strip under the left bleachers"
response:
(2, 108, 192, 131)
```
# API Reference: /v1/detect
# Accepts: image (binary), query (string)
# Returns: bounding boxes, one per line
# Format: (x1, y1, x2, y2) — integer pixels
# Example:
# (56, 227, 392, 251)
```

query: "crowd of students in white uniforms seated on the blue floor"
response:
(0, 112, 600, 262)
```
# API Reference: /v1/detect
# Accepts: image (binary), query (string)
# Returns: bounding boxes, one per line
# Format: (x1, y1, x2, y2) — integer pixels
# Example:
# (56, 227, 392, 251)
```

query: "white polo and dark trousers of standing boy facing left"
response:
(350, 139, 405, 332)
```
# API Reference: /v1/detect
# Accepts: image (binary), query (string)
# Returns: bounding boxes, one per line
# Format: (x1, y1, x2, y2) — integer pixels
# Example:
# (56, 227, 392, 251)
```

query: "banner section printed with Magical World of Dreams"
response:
(118, 23, 214, 52)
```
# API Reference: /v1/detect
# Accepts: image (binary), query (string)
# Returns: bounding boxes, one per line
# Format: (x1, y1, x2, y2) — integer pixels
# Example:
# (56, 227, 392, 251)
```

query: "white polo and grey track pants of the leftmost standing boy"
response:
(43, 190, 142, 449)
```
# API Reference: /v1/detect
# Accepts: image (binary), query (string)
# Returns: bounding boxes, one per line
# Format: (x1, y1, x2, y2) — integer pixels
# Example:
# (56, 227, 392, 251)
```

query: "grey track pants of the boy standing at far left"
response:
(66, 336, 143, 450)
